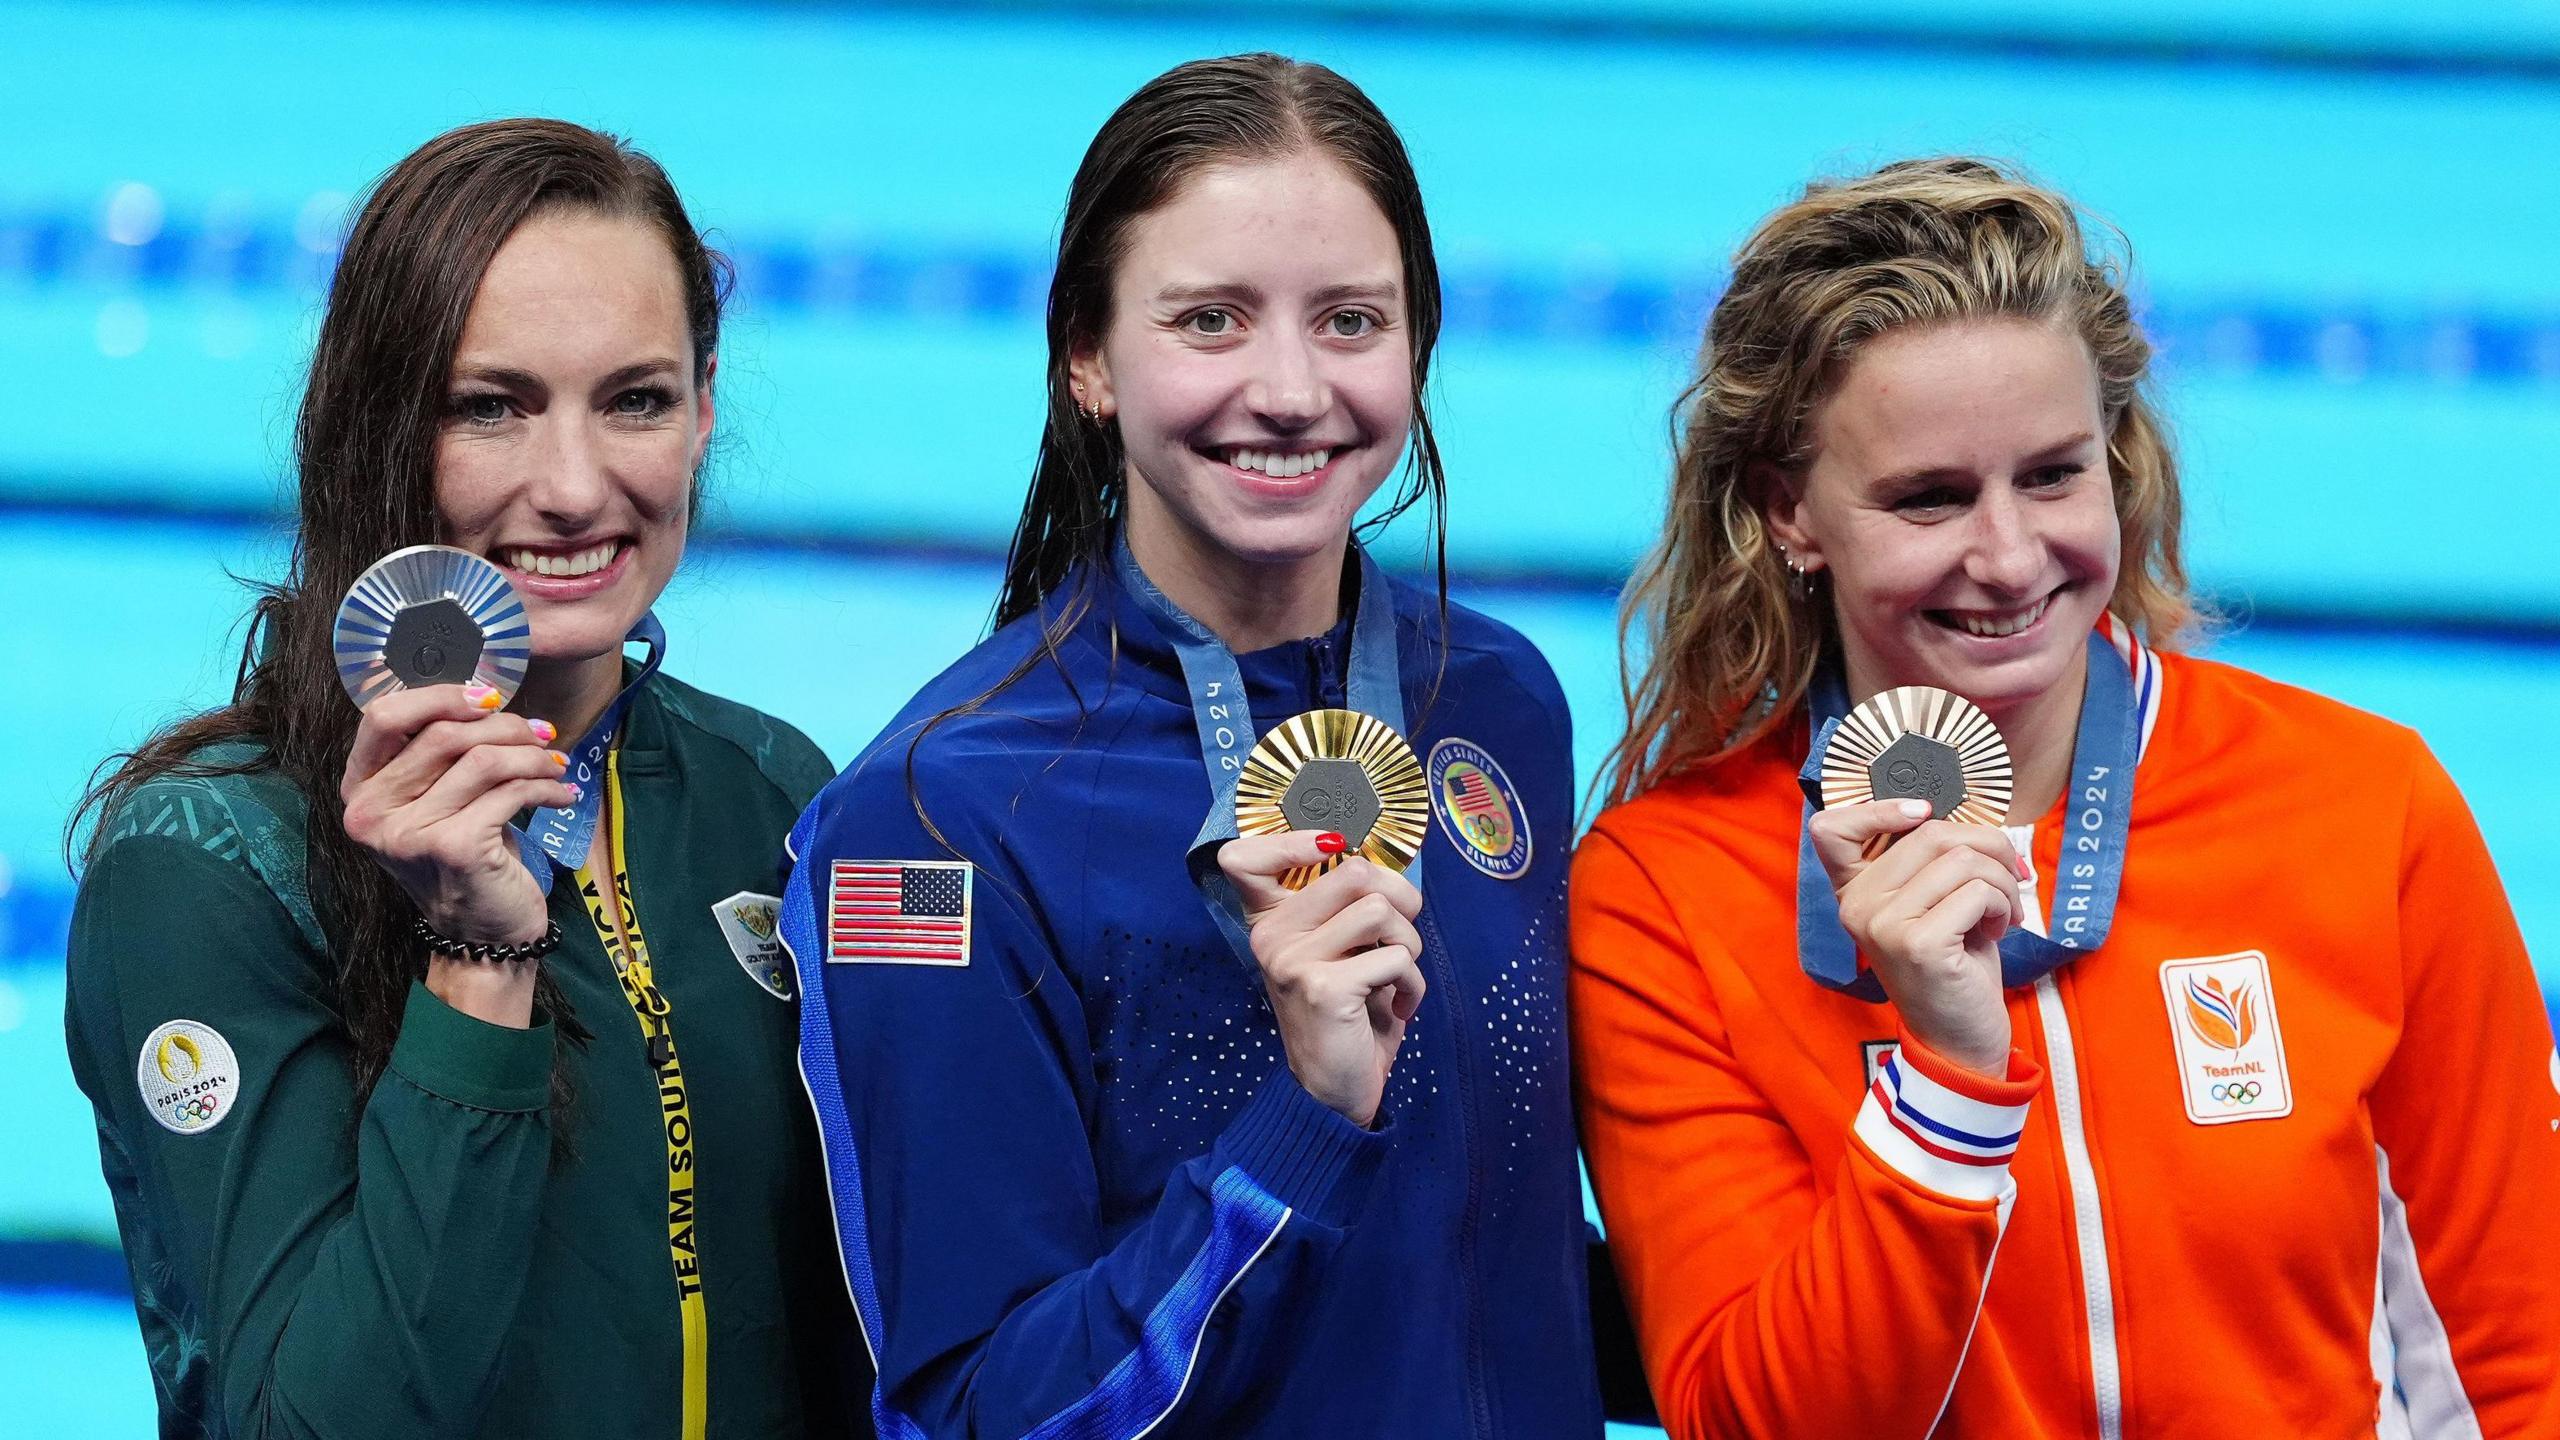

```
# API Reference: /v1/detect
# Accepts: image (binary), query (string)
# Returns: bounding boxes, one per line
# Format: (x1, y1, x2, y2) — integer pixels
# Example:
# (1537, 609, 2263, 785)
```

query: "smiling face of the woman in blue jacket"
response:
(1070, 151, 1413, 579)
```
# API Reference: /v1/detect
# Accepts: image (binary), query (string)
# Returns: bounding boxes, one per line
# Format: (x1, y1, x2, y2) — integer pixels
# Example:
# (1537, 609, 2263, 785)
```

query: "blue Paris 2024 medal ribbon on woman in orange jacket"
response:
(1795, 630, 2143, 999)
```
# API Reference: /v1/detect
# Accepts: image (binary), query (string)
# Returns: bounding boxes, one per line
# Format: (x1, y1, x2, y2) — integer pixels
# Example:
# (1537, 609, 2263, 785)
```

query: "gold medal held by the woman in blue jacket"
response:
(1236, 710, 1431, 889)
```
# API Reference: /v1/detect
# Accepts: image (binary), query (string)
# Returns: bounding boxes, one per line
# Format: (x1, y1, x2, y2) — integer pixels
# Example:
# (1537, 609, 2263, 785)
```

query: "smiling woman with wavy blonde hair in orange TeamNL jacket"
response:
(1572, 159, 2560, 1440)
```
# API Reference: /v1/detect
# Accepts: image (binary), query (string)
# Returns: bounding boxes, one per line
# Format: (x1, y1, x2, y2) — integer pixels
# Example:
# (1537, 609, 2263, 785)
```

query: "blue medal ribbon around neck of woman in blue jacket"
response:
(1116, 536, 1421, 966)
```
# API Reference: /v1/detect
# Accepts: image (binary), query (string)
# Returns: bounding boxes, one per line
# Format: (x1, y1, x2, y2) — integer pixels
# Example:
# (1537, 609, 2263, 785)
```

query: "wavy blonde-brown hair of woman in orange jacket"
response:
(1603, 159, 2199, 802)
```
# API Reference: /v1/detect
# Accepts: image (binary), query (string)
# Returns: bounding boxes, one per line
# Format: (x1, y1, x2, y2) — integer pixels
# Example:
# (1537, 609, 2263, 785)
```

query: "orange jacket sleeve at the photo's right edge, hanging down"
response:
(2371, 732, 2560, 1440)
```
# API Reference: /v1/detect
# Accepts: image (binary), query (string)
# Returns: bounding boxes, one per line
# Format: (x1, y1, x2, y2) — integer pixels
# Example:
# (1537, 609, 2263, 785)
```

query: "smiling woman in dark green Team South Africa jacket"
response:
(69, 120, 865, 1440)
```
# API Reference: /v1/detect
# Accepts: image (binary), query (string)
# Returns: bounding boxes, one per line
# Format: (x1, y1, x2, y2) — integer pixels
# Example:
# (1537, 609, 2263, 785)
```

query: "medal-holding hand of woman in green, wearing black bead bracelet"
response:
(338, 684, 579, 1027)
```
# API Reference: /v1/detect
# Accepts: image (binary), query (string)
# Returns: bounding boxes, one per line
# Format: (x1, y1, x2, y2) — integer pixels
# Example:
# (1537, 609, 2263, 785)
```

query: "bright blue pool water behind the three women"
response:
(20, 0, 2560, 1435)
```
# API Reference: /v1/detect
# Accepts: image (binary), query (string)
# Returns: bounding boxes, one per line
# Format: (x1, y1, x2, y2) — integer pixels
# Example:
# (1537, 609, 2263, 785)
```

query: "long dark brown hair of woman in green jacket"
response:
(67, 120, 730, 1099)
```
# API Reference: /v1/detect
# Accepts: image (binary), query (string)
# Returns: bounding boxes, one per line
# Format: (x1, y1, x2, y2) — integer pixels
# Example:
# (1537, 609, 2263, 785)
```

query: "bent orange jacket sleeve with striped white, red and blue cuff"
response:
(1569, 833, 2043, 1440)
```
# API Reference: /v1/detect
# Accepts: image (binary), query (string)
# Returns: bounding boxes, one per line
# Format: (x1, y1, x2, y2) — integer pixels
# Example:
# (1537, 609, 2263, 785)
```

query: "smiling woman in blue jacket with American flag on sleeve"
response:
(783, 54, 1600, 1440)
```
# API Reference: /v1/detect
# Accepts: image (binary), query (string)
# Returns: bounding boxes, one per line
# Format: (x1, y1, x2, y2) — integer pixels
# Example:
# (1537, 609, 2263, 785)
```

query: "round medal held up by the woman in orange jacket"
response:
(1823, 684, 2010, 825)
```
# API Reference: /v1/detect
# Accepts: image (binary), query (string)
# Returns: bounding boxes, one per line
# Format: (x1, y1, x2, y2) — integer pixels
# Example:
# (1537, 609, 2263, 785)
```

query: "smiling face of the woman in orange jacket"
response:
(1769, 318, 2122, 728)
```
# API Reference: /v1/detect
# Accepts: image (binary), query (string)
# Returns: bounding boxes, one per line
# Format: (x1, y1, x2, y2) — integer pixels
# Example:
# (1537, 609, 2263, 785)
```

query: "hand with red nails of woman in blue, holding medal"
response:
(1219, 830, 1423, 1125)
